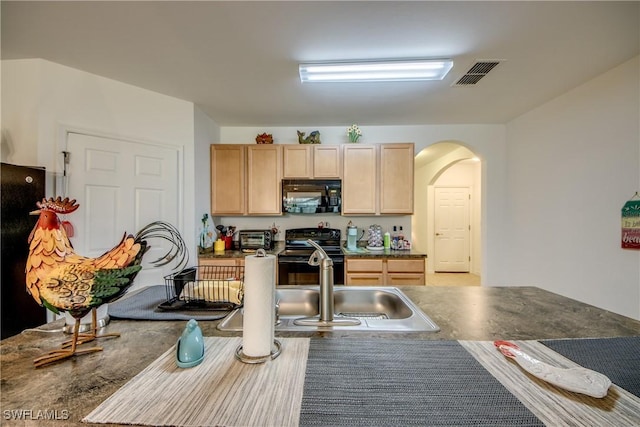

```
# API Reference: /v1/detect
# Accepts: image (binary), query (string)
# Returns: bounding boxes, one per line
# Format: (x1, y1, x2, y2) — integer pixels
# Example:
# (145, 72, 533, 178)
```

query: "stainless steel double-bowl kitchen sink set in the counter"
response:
(218, 286, 440, 332)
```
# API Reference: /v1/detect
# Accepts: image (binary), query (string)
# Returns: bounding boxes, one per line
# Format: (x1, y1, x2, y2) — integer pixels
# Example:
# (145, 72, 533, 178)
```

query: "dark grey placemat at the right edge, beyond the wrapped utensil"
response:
(541, 336, 640, 397)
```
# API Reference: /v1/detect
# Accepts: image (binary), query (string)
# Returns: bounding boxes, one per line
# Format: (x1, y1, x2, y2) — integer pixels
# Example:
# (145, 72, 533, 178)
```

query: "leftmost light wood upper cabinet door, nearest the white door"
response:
(211, 144, 245, 215)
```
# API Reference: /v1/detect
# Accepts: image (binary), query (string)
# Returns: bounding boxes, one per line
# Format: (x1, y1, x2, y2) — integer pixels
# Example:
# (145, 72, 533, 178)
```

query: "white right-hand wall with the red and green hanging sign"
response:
(504, 57, 640, 319)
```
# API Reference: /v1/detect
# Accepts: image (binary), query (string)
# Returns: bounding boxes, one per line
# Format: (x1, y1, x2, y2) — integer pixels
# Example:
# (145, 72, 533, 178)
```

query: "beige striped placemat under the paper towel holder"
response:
(83, 337, 309, 427)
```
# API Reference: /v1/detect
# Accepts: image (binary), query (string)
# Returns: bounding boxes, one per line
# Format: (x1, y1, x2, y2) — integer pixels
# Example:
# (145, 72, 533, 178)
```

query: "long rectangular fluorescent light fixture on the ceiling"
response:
(298, 59, 453, 83)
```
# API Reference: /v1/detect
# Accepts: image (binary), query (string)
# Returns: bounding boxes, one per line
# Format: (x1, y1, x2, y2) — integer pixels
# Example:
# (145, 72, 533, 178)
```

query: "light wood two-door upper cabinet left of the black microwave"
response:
(211, 144, 282, 215)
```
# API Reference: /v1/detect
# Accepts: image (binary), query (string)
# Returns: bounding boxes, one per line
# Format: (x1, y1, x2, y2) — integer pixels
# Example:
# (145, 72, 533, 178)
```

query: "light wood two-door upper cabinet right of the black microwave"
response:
(342, 143, 414, 215)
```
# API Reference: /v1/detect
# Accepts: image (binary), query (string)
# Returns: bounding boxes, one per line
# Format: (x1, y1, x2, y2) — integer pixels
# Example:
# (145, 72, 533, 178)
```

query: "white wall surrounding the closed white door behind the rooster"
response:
(1, 59, 196, 266)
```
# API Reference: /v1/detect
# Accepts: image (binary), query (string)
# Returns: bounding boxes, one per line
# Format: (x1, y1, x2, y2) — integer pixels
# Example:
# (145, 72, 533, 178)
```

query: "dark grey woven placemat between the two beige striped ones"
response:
(300, 338, 544, 427)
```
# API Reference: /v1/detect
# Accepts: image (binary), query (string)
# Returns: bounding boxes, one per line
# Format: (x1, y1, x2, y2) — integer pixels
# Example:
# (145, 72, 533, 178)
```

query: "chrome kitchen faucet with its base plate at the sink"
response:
(293, 239, 360, 326)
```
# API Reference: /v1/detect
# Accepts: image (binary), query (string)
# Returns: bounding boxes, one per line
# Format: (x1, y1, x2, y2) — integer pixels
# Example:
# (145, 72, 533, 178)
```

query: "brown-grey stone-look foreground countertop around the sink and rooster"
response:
(0, 286, 640, 426)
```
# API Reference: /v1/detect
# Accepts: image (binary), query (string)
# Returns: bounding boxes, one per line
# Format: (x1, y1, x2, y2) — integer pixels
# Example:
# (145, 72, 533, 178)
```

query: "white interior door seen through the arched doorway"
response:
(433, 187, 471, 272)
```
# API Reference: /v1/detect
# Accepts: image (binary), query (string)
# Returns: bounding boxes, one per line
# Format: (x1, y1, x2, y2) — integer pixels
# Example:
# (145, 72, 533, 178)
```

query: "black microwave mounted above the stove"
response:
(282, 179, 342, 214)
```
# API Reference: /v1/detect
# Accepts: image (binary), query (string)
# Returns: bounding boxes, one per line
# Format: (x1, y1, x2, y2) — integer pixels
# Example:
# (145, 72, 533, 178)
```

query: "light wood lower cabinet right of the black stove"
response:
(344, 256, 425, 286)
